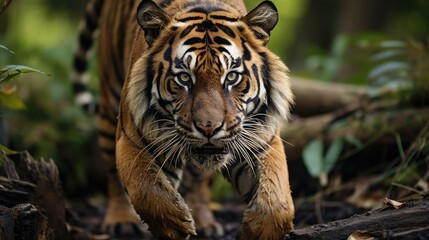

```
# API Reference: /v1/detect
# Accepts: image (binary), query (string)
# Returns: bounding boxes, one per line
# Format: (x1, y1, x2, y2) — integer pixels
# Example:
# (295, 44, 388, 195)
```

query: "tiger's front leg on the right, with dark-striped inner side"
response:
(223, 136, 294, 240)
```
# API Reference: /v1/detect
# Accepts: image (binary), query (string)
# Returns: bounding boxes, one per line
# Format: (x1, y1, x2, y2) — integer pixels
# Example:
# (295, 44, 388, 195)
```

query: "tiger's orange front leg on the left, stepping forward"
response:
(116, 132, 196, 239)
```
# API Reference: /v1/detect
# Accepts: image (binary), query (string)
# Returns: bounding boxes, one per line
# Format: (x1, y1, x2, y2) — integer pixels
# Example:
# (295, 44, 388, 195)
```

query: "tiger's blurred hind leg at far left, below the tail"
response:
(99, 108, 143, 236)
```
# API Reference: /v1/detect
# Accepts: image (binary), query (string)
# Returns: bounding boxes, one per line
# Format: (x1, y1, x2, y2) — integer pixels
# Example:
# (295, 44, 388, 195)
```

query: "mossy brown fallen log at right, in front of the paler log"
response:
(281, 108, 429, 166)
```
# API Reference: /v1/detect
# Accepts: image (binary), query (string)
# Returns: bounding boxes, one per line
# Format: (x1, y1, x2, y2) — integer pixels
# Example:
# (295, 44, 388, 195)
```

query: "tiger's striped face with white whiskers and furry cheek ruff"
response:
(128, 0, 291, 169)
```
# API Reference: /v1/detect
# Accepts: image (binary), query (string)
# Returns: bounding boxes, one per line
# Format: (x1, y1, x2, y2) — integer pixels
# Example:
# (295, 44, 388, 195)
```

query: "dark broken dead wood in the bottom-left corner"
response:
(0, 151, 68, 239)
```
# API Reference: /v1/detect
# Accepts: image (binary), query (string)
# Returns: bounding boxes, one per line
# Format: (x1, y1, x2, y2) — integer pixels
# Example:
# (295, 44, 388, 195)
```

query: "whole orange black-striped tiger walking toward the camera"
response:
(73, 0, 294, 239)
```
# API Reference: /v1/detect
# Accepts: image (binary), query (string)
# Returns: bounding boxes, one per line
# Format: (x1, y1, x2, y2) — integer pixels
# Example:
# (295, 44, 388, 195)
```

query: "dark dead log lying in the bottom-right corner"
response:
(285, 201, 429, 240)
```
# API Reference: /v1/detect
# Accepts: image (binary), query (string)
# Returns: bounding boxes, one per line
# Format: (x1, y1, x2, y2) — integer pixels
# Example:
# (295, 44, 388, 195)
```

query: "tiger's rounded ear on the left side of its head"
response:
(137, 0, 170, 45)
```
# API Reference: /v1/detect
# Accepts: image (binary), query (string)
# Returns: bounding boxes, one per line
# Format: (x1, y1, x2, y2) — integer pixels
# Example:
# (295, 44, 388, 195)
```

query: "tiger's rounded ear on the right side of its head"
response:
(243, 1, 279, 44)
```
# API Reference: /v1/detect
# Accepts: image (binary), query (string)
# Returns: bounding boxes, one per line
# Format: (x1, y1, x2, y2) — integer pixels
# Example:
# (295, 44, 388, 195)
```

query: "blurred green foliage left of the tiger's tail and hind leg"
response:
(0, 1, 96, 193)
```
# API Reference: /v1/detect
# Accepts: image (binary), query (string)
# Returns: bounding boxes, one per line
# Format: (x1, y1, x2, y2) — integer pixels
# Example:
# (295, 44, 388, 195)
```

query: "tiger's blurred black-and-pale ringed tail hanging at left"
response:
(71, 0, 104, 113)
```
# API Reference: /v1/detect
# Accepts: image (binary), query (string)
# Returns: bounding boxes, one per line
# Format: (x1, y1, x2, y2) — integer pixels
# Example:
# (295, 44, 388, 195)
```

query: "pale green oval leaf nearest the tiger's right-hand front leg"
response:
(302, 138, 323, 177)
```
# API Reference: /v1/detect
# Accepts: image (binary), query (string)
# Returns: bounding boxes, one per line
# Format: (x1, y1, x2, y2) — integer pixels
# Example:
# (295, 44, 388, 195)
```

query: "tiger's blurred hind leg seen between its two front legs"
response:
(179, 165, 224, 239)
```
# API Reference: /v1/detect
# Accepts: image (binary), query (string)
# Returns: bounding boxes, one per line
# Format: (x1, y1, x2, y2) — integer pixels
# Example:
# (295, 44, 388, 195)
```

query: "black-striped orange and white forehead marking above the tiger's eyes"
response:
(172, 9, 242, 72)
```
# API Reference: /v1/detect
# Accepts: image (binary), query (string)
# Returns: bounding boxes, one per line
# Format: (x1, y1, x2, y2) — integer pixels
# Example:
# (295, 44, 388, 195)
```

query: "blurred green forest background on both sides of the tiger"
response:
(0, 0, 429, 221)
